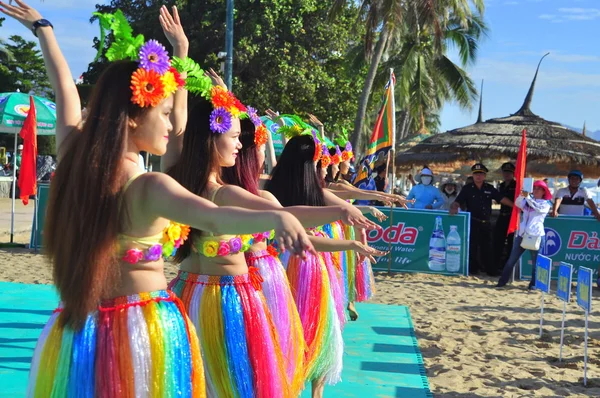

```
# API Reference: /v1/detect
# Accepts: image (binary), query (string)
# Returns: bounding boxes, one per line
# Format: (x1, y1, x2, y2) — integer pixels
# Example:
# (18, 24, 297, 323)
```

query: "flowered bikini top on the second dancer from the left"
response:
(192, 186, 275, 257)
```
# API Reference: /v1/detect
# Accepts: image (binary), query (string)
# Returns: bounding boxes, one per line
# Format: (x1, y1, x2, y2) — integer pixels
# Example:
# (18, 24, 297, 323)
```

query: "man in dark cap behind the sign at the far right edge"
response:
(550, 170, 600, 221)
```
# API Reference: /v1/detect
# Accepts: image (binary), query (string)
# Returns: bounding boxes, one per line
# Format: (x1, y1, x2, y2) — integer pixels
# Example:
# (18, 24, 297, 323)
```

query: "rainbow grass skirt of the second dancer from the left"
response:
(170, 271, 290, 398)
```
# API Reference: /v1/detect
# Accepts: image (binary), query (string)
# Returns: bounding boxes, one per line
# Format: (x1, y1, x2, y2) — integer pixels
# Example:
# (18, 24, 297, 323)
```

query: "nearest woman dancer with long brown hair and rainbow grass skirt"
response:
(0, 0, 311, 397)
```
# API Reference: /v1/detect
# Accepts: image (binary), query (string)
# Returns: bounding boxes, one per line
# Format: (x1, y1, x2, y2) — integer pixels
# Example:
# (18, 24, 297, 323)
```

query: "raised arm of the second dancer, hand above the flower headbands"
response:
(158, 6, 190, 172)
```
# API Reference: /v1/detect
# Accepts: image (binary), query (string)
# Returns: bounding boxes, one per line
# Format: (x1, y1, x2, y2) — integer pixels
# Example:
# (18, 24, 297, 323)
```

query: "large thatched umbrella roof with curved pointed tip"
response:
(396, 54, 600, 176)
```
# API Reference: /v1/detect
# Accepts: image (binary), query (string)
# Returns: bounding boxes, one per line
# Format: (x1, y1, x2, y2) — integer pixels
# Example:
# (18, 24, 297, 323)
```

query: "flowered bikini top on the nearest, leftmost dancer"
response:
(118, 173, 190, 264)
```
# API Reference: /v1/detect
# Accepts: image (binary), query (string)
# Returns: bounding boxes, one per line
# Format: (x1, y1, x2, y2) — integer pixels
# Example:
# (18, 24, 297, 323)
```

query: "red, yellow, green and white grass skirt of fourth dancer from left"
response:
(287, 250, 344, 384)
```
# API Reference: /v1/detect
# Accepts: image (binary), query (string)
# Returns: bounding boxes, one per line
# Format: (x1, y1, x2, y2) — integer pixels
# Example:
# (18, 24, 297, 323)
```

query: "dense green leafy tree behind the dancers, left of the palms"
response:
(84, 0, 363, 135)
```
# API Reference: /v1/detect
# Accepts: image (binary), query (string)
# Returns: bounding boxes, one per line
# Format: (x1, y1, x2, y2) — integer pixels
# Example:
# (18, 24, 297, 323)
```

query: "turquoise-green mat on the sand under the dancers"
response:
(0, 282, 432, 398)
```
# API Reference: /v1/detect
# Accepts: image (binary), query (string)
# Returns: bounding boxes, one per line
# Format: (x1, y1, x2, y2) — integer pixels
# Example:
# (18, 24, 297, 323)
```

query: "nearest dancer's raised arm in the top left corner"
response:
(0, 0, 81, 159)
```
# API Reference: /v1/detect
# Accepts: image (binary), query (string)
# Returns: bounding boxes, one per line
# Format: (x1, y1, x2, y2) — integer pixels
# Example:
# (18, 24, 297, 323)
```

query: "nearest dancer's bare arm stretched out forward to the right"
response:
(140, 173, 314, 254)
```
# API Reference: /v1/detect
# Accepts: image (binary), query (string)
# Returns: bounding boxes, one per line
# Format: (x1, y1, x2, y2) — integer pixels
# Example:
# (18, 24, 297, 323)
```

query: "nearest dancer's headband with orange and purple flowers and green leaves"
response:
(93, 10, 212, 108)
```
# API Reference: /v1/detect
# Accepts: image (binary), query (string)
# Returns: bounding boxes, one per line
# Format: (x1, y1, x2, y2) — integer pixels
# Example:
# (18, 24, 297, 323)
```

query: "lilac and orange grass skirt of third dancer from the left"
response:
(246, 250, 306, 396)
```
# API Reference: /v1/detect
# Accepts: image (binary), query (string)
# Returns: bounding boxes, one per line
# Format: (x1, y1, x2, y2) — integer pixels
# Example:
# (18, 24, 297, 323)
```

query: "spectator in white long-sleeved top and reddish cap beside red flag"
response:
(496, 181, 552, 290)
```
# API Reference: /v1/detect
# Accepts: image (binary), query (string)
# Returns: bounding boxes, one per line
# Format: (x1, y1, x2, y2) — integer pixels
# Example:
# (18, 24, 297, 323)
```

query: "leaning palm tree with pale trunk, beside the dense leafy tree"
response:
(331, 0, 484, 154)
